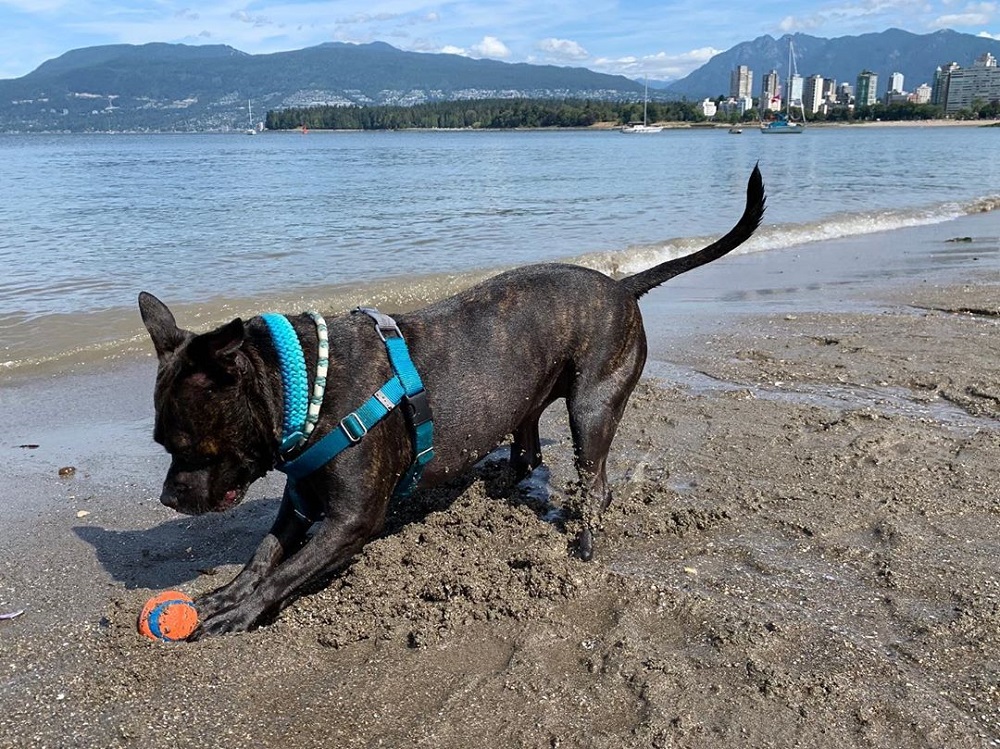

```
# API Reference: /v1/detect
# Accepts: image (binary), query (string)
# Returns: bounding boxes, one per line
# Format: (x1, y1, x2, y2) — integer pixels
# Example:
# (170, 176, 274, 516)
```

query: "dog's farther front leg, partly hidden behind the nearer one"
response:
(195, 489, 312, 621)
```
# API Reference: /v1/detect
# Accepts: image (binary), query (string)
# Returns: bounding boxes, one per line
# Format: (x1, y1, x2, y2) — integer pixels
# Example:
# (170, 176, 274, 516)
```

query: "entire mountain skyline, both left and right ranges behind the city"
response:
(0, 29, 1000, 132)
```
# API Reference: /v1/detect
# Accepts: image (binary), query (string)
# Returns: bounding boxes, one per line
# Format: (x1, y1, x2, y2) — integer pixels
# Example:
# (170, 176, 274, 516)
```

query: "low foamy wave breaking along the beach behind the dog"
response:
(0, 195, 1000, 380)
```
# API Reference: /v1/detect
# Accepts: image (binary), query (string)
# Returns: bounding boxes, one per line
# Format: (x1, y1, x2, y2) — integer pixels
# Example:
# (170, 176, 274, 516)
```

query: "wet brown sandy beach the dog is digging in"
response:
(0, 215, 1000, 749)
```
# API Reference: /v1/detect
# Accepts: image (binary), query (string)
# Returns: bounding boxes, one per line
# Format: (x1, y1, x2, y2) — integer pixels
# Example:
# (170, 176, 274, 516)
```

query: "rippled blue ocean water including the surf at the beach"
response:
(0, 127, 1000, 373)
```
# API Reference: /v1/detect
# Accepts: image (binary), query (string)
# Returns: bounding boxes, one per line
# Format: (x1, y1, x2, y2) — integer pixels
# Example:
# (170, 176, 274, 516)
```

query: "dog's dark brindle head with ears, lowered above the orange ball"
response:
(139, 292, 274, 515)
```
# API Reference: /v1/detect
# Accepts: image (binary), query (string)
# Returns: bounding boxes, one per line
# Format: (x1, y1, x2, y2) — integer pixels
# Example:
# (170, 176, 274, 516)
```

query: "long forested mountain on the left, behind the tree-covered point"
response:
(0, 42, 642, 131)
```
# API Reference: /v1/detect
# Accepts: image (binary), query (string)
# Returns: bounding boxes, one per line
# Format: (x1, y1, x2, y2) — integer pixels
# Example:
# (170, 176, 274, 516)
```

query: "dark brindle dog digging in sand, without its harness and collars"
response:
(139, 167, 765, 638)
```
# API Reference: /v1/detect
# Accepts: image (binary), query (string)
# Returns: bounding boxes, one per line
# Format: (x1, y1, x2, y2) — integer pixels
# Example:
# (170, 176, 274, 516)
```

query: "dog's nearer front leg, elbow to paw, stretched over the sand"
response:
(191, 502, 377, 639)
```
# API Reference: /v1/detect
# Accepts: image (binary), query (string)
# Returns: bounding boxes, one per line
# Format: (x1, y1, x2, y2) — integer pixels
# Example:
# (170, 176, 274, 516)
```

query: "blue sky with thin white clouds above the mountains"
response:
(0, 0, 1000, 80)
